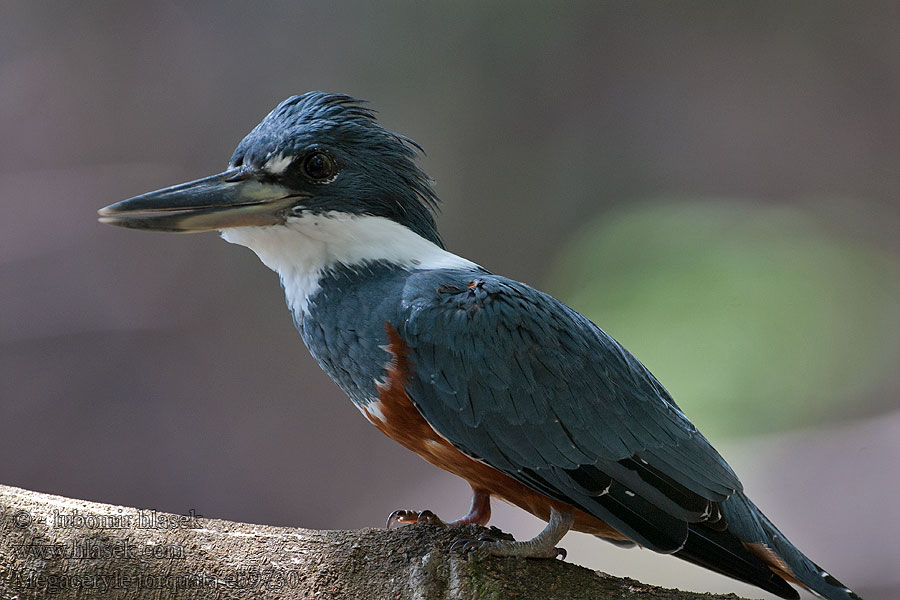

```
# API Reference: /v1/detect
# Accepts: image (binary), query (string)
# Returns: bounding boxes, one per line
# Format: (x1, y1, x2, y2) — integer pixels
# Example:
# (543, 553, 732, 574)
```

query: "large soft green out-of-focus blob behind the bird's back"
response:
(550, 201, 900, 437)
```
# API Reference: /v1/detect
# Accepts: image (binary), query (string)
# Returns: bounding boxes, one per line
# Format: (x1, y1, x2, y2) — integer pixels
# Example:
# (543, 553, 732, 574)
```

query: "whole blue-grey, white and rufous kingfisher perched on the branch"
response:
(98, 92, 859, 600)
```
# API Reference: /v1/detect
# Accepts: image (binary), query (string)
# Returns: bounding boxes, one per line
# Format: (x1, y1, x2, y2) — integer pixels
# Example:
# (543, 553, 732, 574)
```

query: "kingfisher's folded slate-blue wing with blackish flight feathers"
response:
(396, 271, 741, 552)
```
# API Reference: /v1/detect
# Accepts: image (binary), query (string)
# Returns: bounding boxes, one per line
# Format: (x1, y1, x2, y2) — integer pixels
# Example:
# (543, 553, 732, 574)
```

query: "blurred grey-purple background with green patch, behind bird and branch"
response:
(0, 1, 900, 600)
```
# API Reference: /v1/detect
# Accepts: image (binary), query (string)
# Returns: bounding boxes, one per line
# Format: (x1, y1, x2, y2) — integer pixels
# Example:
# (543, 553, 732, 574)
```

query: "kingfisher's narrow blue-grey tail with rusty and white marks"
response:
(722, 492, 862, 600)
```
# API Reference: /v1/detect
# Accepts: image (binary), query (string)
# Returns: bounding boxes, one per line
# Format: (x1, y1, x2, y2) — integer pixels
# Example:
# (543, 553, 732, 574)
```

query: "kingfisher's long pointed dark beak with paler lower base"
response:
(97, 168, 299, 233)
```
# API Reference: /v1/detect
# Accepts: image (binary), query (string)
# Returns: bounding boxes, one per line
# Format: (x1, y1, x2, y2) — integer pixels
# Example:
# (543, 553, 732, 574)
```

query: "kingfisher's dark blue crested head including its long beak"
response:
(99, 92, 441, 246)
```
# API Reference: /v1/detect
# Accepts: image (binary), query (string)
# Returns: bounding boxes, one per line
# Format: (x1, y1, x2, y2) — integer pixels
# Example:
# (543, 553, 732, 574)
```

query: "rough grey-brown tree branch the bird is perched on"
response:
(0, 486, 752, 600)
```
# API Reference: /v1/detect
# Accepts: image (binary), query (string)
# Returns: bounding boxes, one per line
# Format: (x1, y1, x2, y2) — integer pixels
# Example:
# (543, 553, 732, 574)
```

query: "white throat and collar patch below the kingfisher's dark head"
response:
(221, 212, 478, 316)
